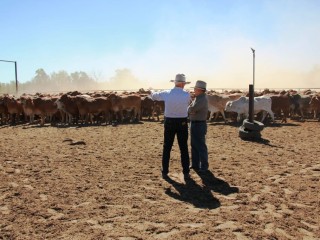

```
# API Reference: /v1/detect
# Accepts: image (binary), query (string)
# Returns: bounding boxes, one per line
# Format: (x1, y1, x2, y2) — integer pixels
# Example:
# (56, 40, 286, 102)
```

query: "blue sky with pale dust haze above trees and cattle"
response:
(0, 0, 320, 88)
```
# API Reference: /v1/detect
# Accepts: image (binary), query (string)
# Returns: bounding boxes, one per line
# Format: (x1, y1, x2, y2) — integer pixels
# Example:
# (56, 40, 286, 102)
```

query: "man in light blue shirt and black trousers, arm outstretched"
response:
(151, 74, 191, 178)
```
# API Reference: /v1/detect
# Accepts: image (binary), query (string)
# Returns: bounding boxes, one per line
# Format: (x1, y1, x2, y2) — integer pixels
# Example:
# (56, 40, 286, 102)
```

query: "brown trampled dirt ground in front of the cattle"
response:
(0, 121, 320, 240)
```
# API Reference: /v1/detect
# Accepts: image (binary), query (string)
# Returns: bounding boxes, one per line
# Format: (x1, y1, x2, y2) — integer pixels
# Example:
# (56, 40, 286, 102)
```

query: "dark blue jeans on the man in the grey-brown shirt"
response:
(190, 121, 209, 170)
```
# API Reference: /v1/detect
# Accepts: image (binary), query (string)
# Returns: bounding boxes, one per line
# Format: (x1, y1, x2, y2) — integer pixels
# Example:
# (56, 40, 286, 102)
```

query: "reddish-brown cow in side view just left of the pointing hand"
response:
(109, 94, 141, 122)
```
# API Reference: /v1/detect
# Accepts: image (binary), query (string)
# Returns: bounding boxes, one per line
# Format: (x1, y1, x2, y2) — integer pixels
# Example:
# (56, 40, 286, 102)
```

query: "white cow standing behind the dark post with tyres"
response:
(225, 96, 274, 122)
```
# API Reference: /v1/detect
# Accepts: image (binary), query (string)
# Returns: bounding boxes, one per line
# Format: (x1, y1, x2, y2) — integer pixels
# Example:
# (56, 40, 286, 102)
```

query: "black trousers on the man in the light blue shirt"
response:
(162, 118, 190, 174)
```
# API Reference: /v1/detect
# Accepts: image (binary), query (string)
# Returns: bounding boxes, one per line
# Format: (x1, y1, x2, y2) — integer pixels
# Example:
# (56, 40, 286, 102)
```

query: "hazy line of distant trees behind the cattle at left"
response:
(0, 68, 140, 94)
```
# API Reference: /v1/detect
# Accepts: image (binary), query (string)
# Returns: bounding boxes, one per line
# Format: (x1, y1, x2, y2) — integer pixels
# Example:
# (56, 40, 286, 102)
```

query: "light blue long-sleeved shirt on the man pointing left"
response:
(151, 87, 191, 118)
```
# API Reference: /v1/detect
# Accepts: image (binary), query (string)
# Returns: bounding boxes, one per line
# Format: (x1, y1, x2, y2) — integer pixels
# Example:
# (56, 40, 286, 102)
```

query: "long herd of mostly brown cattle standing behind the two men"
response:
(0, 89, 320, 126)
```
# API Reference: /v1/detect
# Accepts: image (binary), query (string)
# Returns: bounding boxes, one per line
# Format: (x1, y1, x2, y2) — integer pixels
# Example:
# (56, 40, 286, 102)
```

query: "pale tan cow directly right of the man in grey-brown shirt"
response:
(207, 94, 241, 122)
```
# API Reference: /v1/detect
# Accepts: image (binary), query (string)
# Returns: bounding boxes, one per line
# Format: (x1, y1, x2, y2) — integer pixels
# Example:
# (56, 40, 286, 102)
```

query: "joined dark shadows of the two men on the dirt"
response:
(165, 171, 239, 209)
